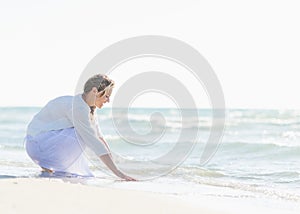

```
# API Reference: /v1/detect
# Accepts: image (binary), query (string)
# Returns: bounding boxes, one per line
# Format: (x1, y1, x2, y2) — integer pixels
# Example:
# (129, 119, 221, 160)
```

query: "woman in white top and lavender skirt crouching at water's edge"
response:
(26, 74, 135, 181)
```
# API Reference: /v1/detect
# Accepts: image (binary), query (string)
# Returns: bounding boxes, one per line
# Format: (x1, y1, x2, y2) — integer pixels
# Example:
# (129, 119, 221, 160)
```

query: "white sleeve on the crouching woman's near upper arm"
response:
(73, 108, 109, 156)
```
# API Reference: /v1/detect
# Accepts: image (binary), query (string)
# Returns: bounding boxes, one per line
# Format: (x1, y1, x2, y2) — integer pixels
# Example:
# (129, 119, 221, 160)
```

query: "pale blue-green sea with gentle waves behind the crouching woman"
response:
(0, 107, 300, 210)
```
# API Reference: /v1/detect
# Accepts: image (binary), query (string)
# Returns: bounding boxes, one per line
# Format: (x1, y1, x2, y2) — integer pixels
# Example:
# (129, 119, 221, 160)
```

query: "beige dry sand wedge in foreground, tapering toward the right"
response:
(0, 178, 219, 214)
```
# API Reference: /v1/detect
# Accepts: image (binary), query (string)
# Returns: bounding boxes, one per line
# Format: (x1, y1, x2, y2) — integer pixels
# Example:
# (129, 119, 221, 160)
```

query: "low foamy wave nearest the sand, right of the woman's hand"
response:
(169, 166, 300, 202)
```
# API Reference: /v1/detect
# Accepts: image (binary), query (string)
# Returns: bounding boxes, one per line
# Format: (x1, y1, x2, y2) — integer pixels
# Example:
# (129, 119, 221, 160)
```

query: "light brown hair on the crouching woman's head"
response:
(83, 74, 115, 97)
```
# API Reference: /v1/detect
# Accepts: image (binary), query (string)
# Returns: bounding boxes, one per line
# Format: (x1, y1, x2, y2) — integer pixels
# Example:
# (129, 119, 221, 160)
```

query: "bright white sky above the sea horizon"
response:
(0, 0, 300, 109)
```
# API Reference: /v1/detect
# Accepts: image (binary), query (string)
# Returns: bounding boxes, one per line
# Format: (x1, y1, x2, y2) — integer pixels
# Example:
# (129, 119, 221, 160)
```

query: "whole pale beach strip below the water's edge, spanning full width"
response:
(0, 178, 300, 214)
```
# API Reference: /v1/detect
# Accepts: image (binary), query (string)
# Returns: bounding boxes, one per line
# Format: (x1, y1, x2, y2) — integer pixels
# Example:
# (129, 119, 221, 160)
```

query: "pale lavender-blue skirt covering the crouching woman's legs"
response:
(26, 128, 92, 176)
